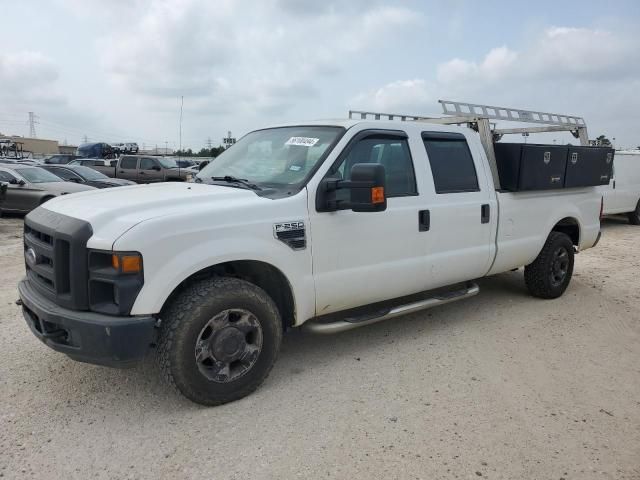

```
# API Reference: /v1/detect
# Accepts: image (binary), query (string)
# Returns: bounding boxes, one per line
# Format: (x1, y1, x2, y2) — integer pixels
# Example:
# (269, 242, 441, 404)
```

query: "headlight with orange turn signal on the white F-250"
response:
(89, 250, 144, 315)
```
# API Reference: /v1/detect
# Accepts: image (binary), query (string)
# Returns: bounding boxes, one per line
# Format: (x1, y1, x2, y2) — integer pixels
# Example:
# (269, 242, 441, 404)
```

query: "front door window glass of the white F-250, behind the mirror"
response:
(329, 134, 418, 200)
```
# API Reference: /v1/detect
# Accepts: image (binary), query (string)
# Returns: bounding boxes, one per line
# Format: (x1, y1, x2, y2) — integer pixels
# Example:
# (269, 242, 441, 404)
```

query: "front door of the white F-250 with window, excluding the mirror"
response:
(309, 130, 428, 315)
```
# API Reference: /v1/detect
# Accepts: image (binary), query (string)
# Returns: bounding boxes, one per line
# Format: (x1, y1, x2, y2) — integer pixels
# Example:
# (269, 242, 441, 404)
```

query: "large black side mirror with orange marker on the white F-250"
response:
(316, 163, 387, 212)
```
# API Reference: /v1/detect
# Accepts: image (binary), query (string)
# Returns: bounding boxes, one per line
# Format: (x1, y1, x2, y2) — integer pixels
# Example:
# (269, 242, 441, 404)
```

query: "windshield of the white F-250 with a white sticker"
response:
(197, 126, 344, 188)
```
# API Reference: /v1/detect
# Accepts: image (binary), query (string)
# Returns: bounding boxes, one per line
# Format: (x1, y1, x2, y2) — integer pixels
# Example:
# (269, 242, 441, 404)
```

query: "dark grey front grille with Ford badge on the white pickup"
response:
(24, 208, 92, 310)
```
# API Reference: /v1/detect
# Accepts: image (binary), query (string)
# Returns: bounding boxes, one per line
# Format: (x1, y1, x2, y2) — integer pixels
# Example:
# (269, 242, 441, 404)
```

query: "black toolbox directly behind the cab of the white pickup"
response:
(494, 143, 569, 192)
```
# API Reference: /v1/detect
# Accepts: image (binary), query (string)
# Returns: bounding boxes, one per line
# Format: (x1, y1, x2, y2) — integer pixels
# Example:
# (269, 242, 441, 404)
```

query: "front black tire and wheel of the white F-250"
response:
(157, 277, 282, 406)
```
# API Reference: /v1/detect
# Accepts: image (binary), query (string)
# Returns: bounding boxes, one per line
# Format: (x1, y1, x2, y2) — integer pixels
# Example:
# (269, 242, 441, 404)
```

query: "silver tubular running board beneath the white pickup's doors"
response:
(303, 282, 480, 334)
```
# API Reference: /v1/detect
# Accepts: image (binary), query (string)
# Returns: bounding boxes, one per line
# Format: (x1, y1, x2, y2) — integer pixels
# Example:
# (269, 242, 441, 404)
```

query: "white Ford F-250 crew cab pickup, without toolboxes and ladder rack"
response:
(19, 103, 601, 405)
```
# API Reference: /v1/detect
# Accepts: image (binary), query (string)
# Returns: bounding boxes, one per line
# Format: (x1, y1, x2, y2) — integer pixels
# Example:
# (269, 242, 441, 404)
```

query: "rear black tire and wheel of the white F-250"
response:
(524, 232, 574, 298)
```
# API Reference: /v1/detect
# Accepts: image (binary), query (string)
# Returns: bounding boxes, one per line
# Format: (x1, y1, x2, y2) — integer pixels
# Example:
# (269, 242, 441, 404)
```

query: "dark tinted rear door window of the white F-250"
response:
(422, 132, 480, 193)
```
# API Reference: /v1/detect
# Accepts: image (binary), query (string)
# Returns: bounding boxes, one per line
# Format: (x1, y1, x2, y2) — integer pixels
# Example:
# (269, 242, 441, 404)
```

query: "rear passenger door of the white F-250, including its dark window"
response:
(422, 131, 497, 285)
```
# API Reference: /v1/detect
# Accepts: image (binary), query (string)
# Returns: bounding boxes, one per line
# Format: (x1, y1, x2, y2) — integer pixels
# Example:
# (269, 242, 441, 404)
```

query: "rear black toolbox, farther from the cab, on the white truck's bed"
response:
(564, 147, 615, 188)
